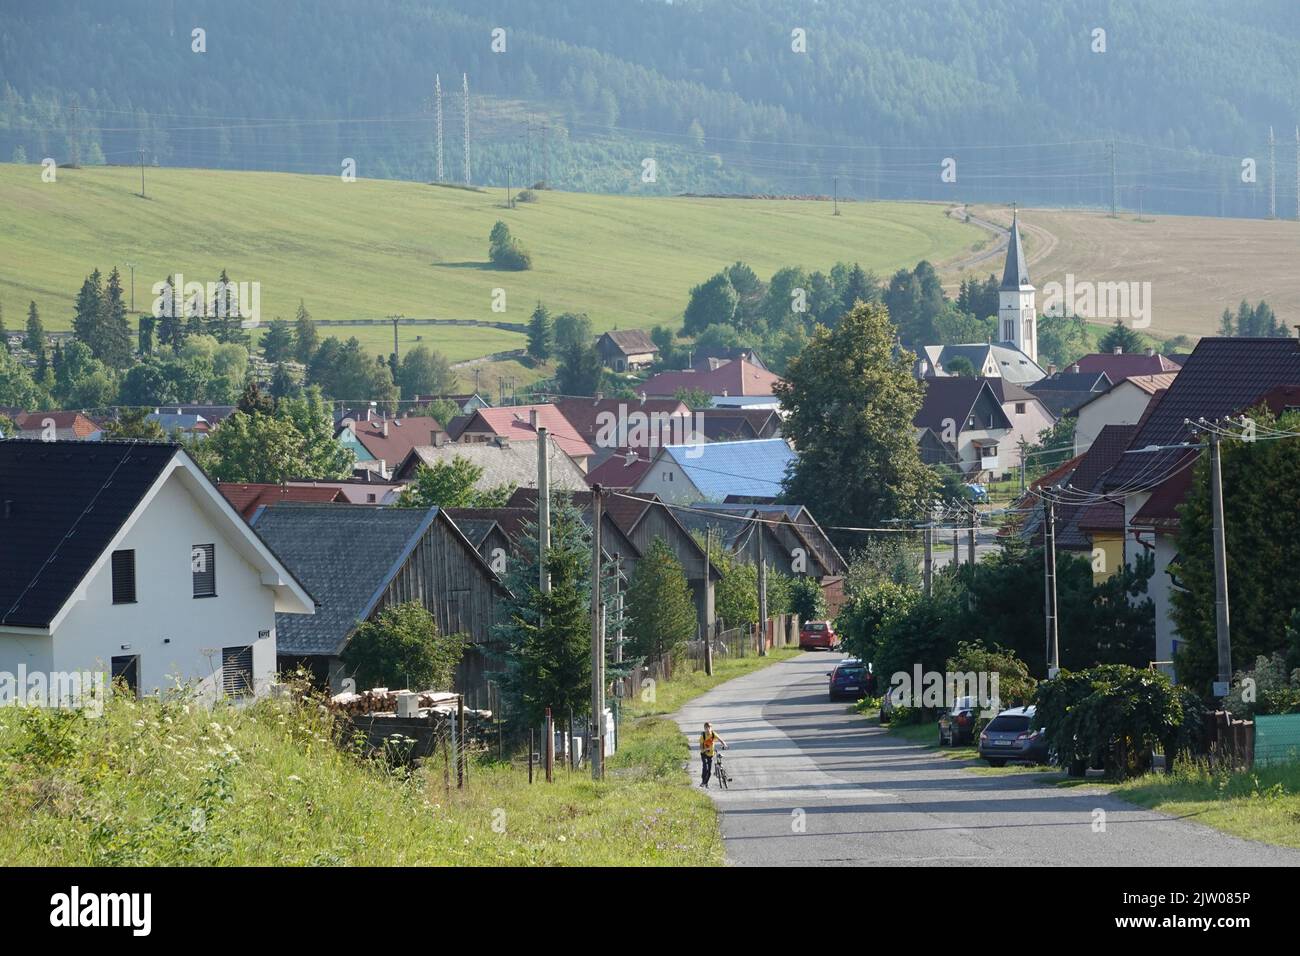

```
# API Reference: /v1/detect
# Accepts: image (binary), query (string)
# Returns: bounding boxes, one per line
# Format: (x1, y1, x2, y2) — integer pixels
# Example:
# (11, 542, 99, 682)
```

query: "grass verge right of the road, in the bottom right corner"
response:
(1114, 763, 1300, 849)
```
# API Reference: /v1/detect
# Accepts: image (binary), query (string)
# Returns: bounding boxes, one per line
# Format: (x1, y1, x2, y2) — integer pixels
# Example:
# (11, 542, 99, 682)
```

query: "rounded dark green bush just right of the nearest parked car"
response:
(1036, 665, 1201, 778)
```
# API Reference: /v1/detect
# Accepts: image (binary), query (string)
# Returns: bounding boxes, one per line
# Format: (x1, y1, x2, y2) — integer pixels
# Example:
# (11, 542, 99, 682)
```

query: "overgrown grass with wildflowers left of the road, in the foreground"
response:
(0, 652, 794, 866)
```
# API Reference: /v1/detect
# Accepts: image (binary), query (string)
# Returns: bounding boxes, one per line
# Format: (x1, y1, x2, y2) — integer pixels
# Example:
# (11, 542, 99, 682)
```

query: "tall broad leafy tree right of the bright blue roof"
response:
(776, 304, 935, 527)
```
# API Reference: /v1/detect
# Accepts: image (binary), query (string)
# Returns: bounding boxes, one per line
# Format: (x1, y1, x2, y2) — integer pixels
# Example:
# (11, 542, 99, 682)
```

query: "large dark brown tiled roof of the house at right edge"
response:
(1106, 337, 1300, 488)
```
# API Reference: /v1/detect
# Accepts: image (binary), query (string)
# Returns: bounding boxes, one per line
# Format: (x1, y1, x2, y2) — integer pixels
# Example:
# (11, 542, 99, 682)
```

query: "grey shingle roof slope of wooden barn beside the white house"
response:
(251, 502, 438, 657)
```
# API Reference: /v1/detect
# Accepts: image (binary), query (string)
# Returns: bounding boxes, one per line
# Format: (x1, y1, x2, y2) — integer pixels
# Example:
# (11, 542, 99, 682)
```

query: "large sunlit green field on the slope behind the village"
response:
(0, 164, 987, 360)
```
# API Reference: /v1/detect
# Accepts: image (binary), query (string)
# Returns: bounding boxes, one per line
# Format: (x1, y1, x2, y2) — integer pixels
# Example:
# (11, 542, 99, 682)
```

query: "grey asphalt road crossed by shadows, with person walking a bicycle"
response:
(676, 653, 1300, 866)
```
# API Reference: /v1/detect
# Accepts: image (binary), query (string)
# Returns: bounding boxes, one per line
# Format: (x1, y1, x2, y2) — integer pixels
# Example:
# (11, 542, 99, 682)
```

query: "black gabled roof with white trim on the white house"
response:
(0, 438, 312, 630)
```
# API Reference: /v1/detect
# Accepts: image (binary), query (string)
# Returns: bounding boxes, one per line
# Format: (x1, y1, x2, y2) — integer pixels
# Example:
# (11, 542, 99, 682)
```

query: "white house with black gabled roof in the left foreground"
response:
(0, 440, 315, 701)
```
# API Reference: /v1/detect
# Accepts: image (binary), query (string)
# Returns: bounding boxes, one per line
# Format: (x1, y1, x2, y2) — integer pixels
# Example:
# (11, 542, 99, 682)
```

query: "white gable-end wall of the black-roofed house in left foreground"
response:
(0, 472, 276, 700)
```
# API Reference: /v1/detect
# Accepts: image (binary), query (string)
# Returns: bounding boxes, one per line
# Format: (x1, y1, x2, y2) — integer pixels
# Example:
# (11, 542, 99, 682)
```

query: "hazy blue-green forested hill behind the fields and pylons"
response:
(0, 0, 1300, 216)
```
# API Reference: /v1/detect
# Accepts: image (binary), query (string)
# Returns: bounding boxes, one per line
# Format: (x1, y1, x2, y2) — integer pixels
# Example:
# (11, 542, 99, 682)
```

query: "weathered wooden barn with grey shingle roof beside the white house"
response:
(251, 502, 506, 692)
